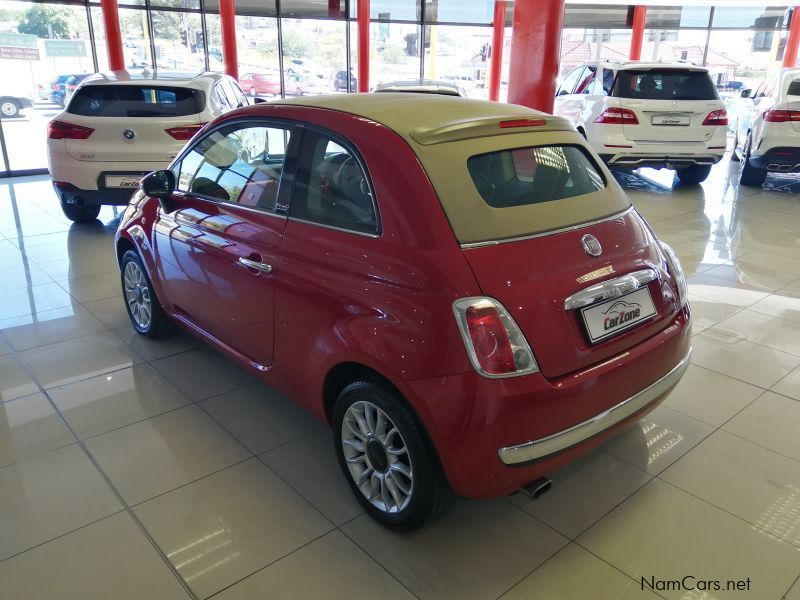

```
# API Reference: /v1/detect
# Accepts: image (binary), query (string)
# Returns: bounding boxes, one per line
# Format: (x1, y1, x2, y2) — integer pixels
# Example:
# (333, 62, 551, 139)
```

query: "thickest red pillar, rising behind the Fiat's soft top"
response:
(508, 0, 564, 112)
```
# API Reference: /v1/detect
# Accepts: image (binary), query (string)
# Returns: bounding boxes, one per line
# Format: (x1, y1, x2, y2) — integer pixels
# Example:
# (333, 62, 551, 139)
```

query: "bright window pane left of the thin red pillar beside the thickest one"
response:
(424, 25, 492, 98)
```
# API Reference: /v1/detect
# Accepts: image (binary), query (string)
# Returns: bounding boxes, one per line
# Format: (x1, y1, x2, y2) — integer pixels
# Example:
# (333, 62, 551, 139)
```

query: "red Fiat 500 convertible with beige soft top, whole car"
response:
(116, 93, 690, 529)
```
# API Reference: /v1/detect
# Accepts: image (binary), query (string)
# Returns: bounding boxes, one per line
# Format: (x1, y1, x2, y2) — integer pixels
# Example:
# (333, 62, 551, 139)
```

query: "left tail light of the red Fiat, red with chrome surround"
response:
(453, 297, 539, 377)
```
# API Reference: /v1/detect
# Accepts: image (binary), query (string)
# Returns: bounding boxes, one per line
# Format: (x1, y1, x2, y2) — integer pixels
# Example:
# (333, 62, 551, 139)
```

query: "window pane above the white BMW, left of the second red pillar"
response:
(150, 10, 205, 71)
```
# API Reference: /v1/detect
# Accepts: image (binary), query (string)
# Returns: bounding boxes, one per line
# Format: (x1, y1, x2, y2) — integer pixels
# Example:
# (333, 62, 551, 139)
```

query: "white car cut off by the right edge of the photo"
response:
(732, 67, 800, 186)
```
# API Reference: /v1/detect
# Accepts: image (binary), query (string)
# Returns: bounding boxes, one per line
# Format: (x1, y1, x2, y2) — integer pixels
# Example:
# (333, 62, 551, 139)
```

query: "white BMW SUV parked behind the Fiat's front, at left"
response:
(47, 71, 248, 222)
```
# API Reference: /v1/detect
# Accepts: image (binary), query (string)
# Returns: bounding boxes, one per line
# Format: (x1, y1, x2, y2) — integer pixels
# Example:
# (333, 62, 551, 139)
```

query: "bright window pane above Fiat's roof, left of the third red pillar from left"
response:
(281, 19, 346, 95)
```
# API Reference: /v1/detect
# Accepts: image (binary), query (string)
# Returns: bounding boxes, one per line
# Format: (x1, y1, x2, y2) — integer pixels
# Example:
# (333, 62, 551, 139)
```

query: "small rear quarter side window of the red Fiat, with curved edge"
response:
(289, 129, 378, 234)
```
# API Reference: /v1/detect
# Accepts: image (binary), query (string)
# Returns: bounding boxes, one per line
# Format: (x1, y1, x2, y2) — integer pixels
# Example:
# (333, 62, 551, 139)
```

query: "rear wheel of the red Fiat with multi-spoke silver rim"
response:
(332, 381, 457, 531)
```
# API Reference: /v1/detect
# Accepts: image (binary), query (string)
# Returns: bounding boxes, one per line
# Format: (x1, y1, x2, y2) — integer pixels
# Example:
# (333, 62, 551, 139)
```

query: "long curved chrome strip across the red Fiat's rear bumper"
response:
(497, 348, 692, 465)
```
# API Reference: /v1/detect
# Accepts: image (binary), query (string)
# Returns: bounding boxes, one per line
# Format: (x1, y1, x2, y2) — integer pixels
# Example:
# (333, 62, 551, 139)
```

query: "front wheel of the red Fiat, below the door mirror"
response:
(119, 250, 174, 338)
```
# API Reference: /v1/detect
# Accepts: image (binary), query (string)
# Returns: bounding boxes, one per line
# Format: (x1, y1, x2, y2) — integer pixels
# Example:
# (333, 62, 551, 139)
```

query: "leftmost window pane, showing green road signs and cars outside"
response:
(0, 2, 94, 171)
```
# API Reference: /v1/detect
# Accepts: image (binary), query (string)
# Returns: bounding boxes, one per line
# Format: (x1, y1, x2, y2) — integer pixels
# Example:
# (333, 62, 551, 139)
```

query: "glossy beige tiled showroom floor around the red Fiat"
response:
(0, 162, 800, 600)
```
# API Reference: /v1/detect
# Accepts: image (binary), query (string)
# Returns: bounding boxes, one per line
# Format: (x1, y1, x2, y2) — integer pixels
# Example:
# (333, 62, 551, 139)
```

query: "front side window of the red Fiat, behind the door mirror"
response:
(178, 125, 290, 212)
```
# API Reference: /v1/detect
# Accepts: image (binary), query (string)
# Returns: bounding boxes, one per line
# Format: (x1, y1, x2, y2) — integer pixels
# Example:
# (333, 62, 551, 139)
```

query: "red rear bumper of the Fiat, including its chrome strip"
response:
(404, 307, 691, 498)
